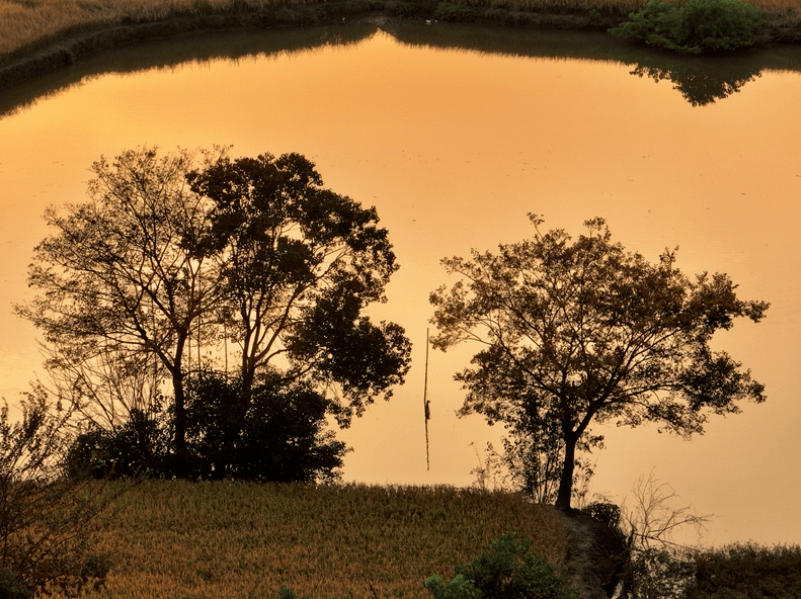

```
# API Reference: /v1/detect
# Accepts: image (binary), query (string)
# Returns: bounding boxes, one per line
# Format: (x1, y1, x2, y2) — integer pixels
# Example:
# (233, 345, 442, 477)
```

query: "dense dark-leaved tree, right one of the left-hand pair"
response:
(188, 154, 411, 425)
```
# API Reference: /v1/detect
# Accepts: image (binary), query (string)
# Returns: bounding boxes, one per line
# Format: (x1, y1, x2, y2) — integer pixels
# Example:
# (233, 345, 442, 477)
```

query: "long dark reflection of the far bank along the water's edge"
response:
(0, 18, 801, 117)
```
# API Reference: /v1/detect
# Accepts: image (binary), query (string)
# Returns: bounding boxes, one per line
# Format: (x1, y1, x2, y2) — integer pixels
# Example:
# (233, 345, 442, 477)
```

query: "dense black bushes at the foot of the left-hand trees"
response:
(66, 372, 346, 482)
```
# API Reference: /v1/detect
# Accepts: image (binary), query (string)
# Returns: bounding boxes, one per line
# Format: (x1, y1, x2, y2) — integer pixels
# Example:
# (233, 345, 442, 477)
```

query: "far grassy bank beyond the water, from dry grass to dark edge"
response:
(0, 0, 801, 85)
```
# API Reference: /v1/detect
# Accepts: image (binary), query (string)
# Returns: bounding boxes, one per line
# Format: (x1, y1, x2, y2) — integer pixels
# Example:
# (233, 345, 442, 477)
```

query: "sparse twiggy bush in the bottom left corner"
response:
(0, 389, 111, 599)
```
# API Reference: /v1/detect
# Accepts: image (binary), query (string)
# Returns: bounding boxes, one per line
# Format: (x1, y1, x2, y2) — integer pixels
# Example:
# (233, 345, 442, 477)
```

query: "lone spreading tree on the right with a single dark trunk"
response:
(430, 215, 769, 508)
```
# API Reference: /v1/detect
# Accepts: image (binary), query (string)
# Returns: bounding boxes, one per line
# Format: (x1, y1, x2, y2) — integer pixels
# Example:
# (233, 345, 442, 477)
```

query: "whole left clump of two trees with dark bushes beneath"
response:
(16, 148, 411, 480)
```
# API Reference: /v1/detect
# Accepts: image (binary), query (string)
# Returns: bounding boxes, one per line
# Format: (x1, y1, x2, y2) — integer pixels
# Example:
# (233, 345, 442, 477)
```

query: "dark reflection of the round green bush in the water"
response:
(631, 62, 761, 106)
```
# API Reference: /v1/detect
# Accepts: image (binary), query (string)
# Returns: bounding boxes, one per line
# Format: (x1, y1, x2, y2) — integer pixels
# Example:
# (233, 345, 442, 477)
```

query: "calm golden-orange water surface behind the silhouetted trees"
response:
(0, 25, 801, 544)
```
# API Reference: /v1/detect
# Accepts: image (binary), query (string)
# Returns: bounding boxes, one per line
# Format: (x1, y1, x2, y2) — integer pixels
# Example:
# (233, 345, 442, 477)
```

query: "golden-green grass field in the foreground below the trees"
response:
(59, 481, 568, 599)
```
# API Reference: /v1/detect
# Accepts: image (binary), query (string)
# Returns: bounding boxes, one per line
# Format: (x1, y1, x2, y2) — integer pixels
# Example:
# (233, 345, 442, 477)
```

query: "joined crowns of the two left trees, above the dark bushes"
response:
(16, 148, 411, 478)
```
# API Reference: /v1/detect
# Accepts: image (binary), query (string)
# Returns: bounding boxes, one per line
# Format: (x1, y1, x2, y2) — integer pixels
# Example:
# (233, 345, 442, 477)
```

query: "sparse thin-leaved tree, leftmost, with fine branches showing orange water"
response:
(16, 149, 219, 474)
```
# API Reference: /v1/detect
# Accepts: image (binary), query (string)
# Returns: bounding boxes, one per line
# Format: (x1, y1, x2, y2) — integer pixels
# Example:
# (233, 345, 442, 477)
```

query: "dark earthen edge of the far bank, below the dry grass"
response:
(0, 0, 801, 90)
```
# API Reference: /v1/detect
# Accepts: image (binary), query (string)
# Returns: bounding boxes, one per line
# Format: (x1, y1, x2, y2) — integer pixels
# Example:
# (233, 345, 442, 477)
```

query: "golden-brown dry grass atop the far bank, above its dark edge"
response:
(0, 0, 801, 62)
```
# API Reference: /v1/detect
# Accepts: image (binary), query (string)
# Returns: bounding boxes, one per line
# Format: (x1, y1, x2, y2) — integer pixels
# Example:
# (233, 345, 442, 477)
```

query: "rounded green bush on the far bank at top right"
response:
(609, 0, 765, 54)
